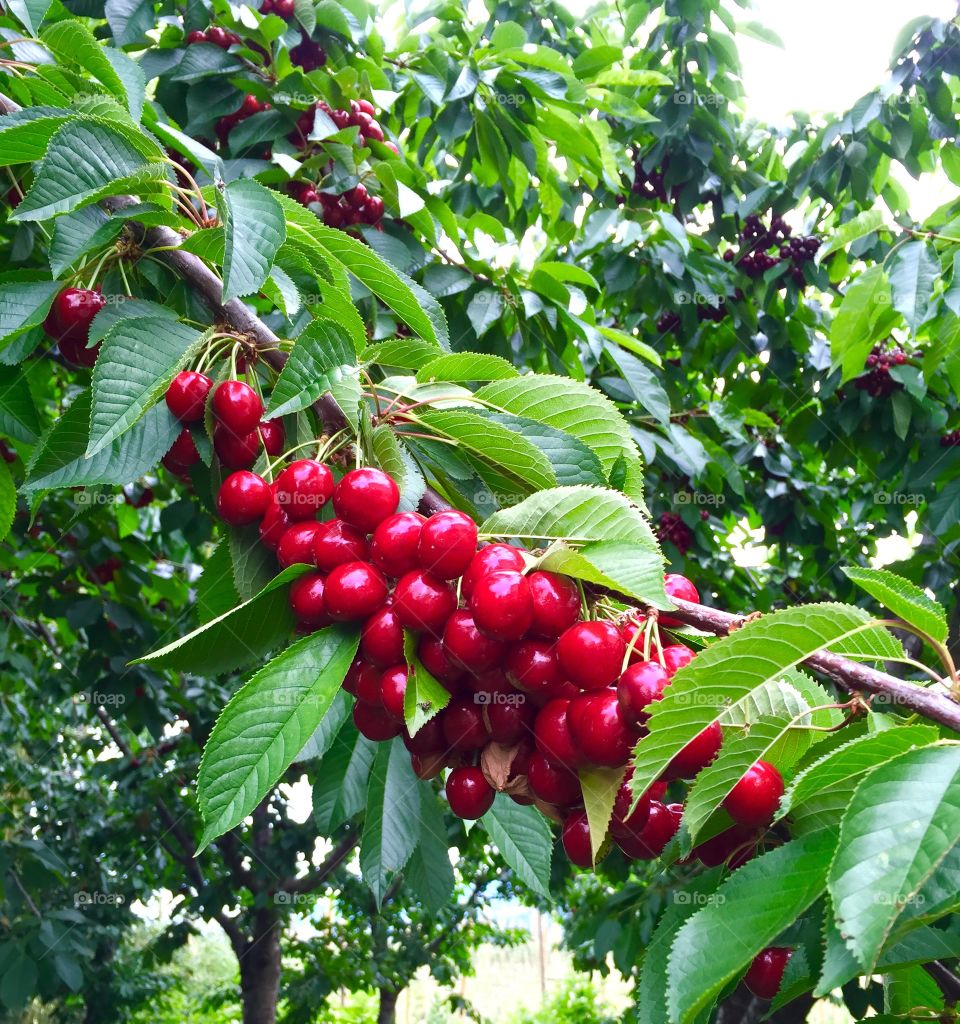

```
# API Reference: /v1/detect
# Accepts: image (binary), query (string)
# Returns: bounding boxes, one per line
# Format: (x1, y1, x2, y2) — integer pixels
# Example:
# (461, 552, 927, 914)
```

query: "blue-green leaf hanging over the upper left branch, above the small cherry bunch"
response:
(223, 178, 287, 302)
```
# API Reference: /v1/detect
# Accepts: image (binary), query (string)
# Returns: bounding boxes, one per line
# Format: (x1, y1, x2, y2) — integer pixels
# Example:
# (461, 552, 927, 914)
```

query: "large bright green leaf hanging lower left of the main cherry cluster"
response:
(197, 626, 359, 852)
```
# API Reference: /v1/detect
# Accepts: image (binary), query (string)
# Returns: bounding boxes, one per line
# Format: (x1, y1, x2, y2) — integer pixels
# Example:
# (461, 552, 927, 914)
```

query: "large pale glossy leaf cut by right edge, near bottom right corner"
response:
(830, 745, 960, 973)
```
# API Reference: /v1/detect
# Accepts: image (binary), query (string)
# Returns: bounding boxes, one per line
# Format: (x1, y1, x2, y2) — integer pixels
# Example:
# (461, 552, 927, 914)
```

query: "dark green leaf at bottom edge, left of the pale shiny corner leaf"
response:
(667, 833, 836, 1024)
